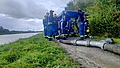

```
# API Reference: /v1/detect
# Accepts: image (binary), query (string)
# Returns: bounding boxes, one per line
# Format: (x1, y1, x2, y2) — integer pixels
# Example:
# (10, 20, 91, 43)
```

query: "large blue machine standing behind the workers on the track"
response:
(58, 10, 79, 39)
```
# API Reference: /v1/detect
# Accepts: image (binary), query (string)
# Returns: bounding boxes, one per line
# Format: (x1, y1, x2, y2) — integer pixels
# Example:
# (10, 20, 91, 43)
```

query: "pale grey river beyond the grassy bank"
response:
(0, 33, 38, 45)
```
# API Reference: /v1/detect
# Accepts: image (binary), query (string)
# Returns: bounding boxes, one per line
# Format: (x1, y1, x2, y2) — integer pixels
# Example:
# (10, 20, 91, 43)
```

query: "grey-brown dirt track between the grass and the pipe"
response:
(55, 38, 120, 68)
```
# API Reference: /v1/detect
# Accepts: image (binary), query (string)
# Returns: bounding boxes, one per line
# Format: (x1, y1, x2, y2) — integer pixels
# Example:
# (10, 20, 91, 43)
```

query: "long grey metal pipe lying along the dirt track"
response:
(59, 40, 120, 54)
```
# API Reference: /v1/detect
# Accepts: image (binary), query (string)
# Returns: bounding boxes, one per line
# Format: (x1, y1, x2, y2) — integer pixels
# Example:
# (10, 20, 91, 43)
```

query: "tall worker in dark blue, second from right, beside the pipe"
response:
(78, 9, 84, 40)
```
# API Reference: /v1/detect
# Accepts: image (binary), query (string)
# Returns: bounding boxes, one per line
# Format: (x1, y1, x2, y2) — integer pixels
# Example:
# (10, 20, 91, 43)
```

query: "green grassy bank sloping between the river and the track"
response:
(0, 34, 80, 68)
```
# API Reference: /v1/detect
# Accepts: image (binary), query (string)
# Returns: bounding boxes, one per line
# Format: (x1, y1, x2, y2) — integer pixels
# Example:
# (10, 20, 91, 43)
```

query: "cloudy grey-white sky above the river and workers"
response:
(0, 0, 70, 31)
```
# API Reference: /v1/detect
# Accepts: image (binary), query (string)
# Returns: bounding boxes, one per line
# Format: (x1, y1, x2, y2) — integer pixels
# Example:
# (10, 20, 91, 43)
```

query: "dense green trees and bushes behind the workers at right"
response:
(65, 0, 120, 38)
